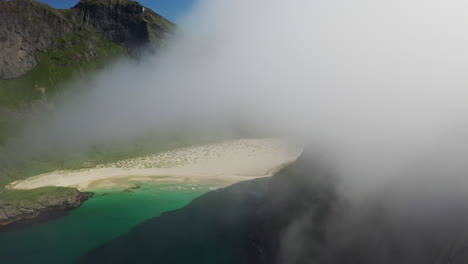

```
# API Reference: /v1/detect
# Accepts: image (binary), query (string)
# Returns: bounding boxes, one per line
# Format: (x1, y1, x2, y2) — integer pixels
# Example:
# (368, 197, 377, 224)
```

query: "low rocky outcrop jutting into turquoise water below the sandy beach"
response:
(0, 189, 92, 231)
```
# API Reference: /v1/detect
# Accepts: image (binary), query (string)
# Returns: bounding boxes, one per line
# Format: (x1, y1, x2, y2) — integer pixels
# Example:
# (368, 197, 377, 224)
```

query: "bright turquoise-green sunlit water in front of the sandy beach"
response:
(0, 184, 215, 264)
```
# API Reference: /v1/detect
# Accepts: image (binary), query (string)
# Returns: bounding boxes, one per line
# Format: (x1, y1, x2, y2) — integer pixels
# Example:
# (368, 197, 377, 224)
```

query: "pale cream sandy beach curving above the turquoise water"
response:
(8, 139, 302, 190)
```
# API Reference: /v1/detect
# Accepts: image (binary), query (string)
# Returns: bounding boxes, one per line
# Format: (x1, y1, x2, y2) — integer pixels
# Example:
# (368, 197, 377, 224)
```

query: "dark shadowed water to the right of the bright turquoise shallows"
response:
(76, 179, 267, 264)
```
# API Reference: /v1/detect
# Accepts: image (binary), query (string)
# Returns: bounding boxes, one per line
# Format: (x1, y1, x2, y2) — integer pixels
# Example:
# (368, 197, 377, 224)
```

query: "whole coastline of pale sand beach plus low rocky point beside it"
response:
(0, 139, 302, 232)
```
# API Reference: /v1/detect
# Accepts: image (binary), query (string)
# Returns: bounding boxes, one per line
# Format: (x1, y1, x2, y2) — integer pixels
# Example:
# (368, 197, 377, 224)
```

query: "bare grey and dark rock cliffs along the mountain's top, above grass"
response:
(0, 0, 173, 79)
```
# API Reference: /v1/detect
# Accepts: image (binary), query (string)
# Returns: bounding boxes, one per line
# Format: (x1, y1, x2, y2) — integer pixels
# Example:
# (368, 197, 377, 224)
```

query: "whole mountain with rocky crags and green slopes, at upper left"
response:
(0, 0, 174, 105)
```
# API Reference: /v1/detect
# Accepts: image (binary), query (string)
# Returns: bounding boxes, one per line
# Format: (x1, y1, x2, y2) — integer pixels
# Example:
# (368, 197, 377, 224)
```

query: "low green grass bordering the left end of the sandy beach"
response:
(0, 137, 189, 224)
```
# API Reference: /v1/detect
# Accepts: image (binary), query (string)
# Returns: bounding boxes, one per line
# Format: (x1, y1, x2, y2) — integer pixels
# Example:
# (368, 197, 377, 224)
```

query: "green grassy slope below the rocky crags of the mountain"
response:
(0, 30, 125, 109)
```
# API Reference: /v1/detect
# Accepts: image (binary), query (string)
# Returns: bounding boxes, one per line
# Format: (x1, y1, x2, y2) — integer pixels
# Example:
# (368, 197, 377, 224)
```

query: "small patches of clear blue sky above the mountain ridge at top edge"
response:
(38, 0, 196, 22)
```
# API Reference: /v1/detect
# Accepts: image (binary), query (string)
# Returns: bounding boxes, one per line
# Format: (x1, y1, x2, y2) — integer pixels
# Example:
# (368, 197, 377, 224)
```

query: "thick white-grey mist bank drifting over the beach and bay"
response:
(7, 0, 468, 263)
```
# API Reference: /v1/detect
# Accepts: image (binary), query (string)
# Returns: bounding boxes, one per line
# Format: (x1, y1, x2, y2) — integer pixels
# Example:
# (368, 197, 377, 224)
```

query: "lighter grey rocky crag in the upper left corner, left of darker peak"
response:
(0, 0, 75, 79)
